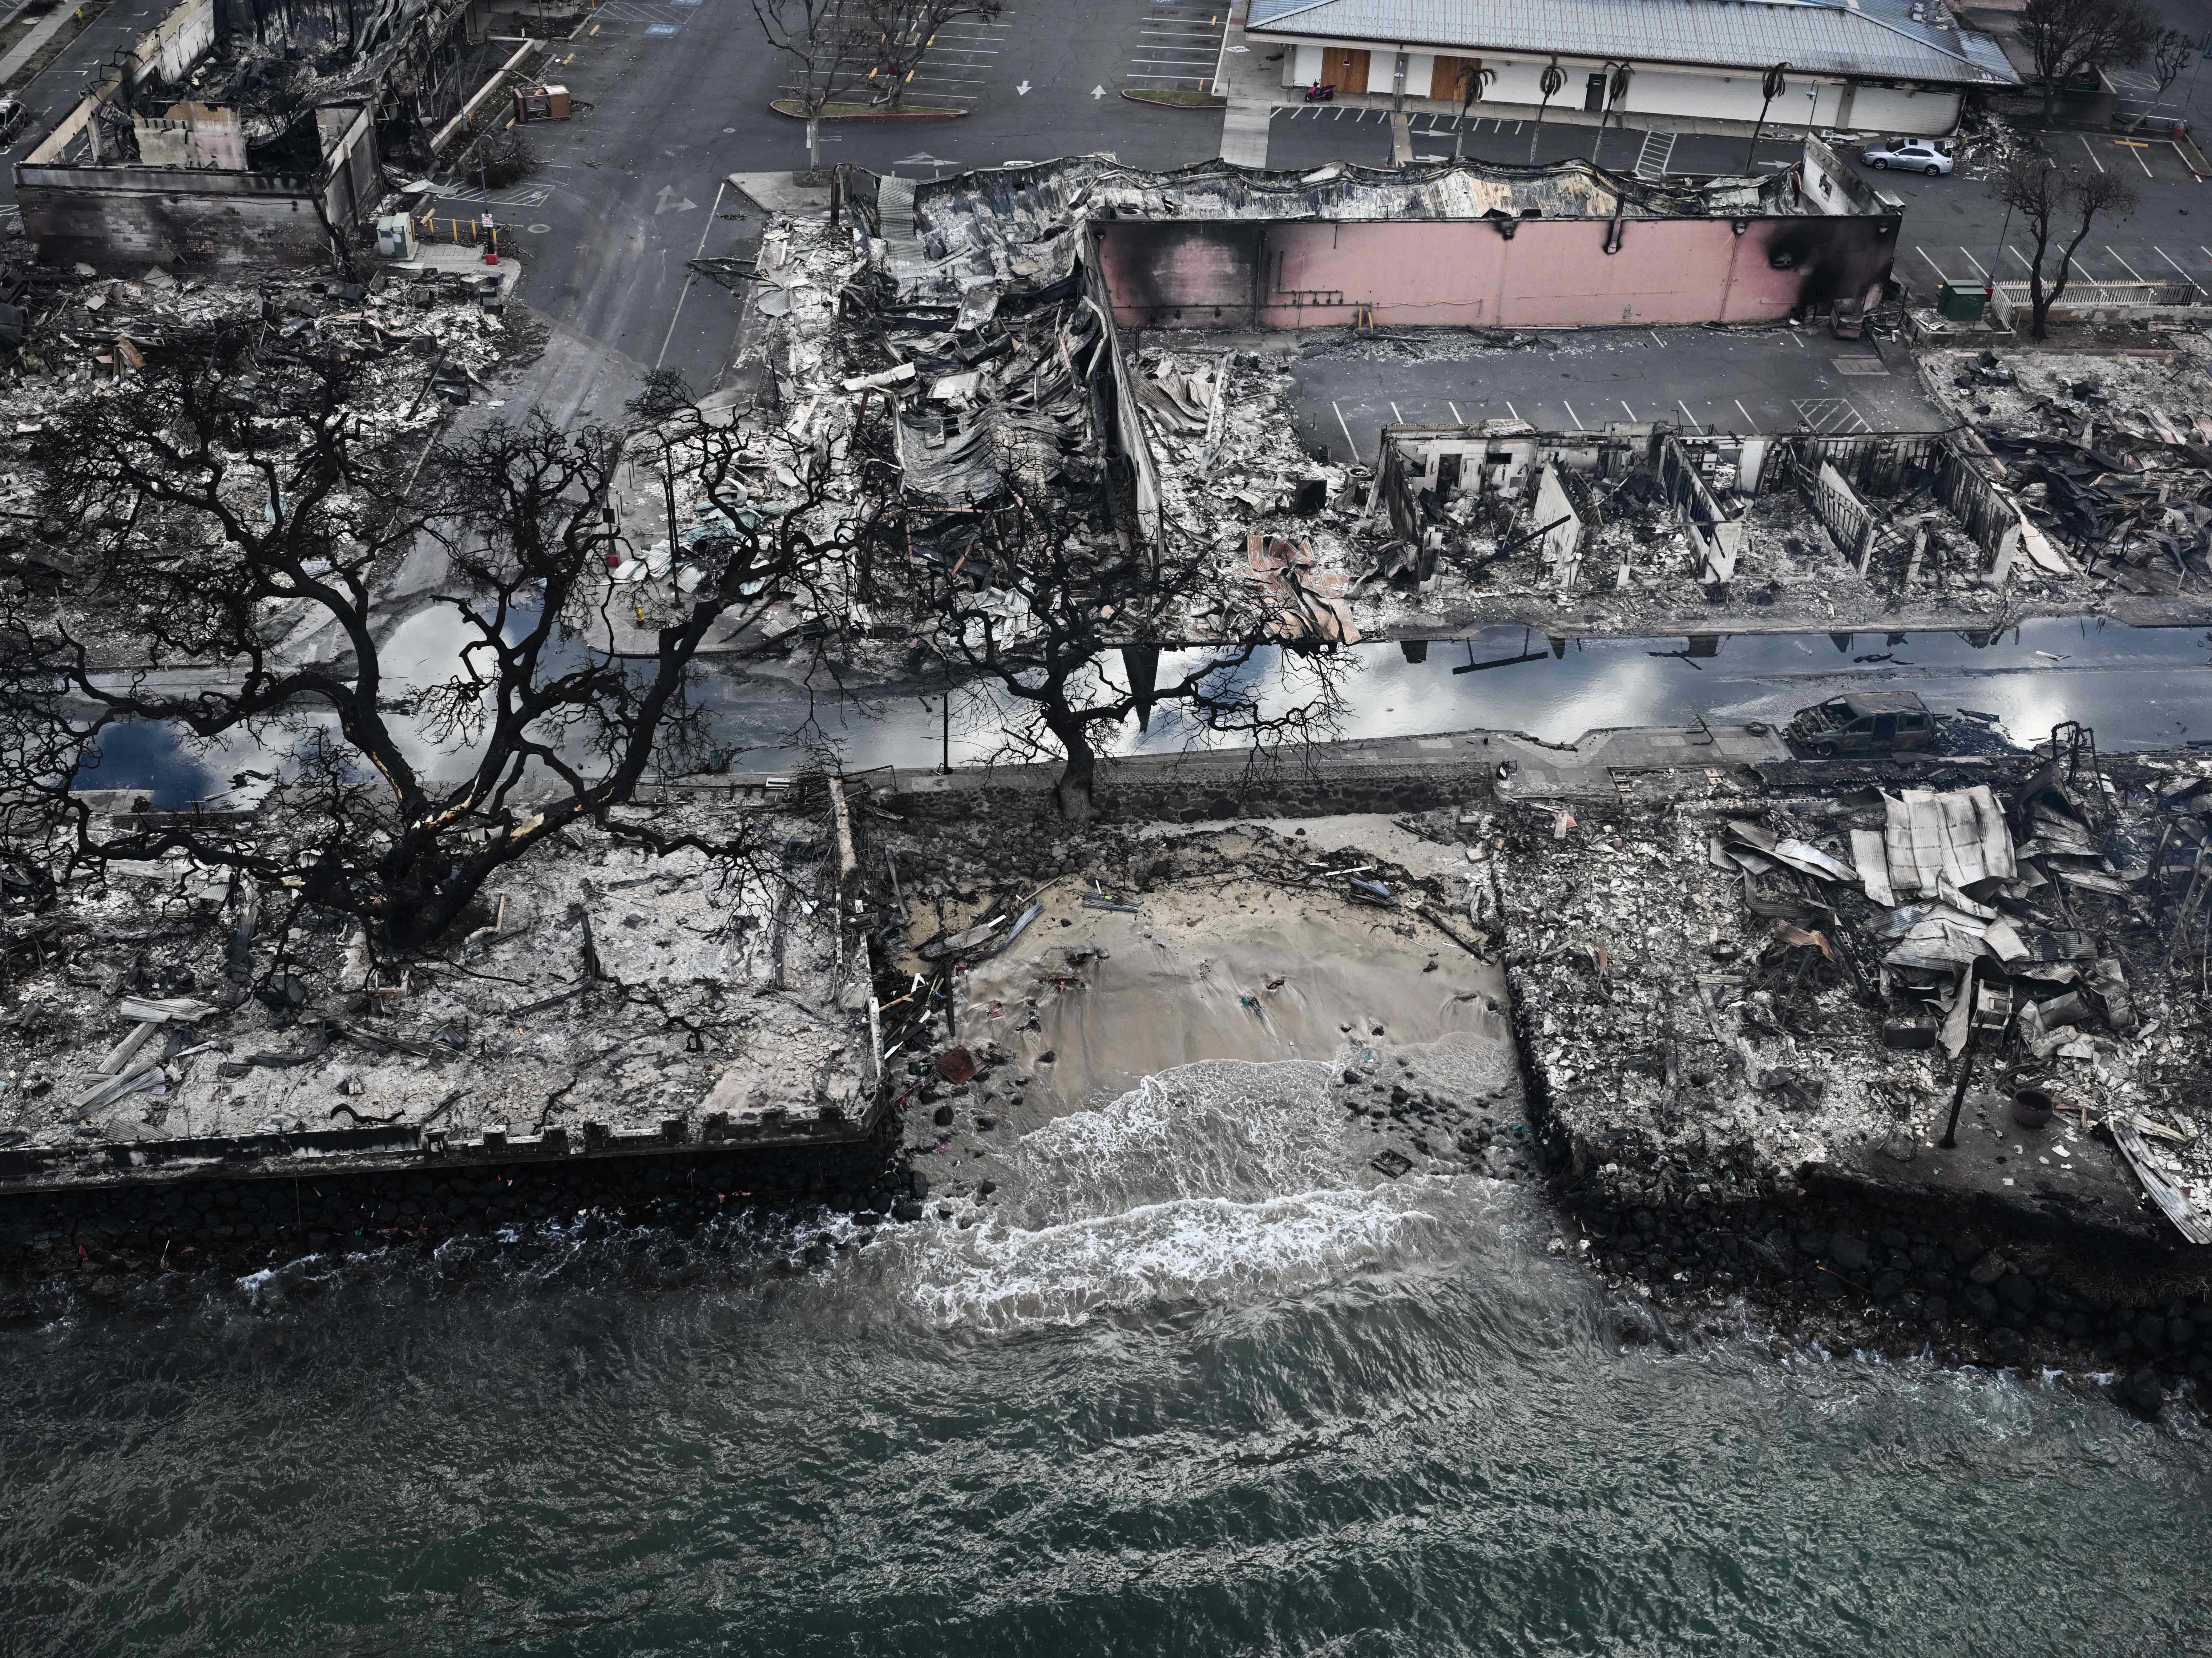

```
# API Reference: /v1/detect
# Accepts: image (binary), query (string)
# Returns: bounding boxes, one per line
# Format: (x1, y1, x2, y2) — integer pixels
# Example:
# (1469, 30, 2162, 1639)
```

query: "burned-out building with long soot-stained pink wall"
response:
(861, 137, 1902, 329)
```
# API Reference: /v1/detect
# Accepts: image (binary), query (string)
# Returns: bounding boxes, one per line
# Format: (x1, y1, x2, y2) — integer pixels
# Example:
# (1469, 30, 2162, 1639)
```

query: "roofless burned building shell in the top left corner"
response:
(15, 0, 469, 268)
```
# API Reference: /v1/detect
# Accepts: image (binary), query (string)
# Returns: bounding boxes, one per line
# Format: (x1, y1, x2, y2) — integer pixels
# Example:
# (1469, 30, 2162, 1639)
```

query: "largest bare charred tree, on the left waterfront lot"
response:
(0, 349, 880, 953)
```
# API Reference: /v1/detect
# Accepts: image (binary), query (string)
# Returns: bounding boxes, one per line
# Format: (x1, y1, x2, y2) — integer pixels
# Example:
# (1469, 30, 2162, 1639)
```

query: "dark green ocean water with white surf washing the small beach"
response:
(0, 1063, 2212, 1658)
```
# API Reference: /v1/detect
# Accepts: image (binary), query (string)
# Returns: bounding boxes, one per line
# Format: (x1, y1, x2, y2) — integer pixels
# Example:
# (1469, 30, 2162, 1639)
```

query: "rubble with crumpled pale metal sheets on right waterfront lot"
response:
(1502, 727, 2212, 1242)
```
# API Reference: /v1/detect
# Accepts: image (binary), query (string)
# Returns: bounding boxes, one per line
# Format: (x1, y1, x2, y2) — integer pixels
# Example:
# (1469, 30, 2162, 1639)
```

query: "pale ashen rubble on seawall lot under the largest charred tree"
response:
(0, 787, 878, 1189)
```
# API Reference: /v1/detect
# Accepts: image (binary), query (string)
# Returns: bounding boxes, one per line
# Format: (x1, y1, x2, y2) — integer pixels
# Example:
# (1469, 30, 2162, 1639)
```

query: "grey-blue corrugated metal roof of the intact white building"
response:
(1245, 0, 2020, 84)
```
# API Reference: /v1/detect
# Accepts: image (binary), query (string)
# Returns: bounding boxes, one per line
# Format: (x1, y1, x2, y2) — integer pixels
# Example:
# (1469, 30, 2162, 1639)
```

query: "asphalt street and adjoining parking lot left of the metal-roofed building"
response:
(365, 0, 1247, 418)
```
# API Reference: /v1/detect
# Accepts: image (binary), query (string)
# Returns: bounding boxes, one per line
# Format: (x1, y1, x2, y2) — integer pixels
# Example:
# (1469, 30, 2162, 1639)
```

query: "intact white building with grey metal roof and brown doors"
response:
(1243, 0, 2020, 135)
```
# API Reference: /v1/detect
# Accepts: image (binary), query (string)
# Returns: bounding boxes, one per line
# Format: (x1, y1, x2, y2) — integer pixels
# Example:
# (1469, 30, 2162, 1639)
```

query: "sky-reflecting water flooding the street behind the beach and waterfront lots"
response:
(84, 619, 2212, 807)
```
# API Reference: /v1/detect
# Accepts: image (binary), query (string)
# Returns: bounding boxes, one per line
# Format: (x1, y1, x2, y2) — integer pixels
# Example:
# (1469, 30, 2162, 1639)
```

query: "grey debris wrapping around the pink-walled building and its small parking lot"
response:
(679, 150, 2212, 643)
